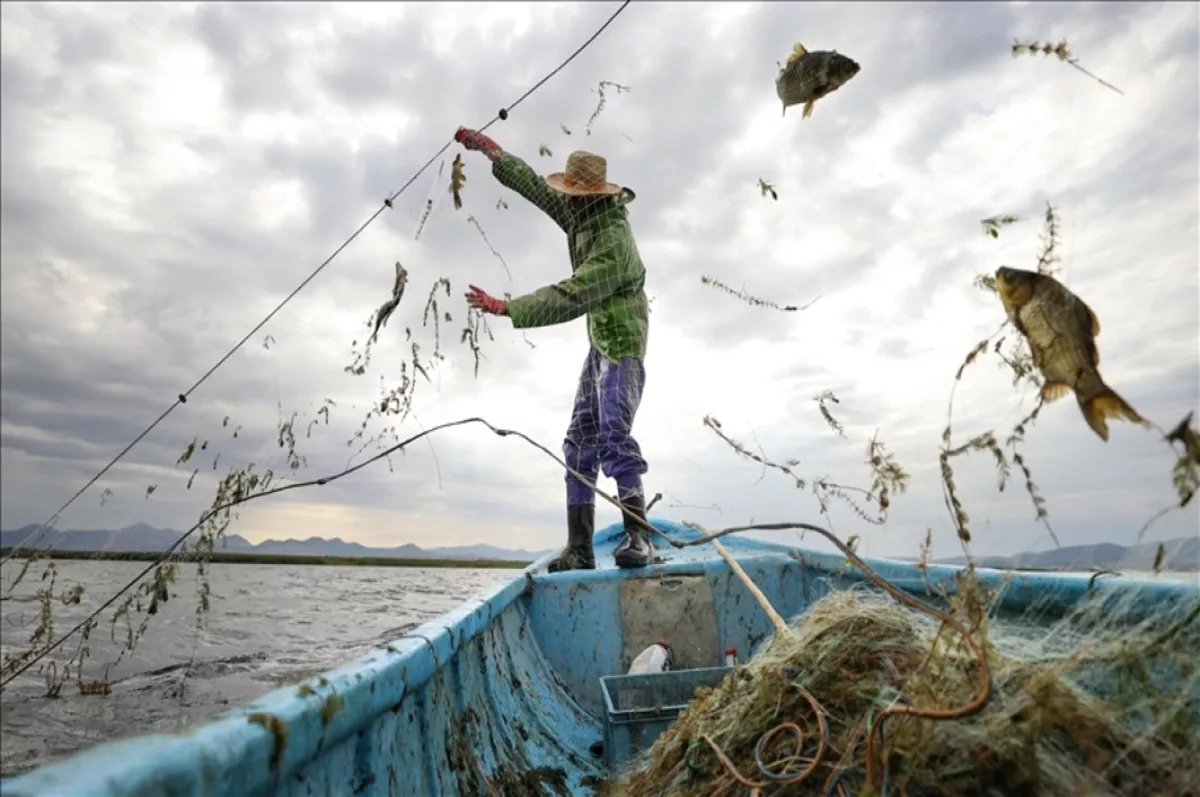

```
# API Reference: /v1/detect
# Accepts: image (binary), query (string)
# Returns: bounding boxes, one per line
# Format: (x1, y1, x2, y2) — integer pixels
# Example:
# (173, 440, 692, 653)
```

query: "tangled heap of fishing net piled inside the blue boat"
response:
(612, 585, 1200, 797)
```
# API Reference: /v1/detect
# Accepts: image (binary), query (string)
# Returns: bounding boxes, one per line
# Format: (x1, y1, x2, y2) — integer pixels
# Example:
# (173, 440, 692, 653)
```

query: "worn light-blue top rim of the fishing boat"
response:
(0, 519, 1200, 797)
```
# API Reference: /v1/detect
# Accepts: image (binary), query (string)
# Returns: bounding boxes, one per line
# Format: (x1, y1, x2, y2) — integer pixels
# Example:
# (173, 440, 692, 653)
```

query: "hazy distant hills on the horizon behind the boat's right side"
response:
(936, 535, 1200, 573)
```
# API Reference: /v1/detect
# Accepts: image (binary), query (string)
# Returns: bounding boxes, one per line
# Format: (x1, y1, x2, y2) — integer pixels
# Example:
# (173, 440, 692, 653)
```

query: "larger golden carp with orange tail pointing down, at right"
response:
(996, 265, 1150, 441)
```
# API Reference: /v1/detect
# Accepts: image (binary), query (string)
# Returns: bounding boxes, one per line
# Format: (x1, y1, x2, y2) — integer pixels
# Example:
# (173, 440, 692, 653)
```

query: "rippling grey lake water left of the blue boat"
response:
(0, 561, 520, 777)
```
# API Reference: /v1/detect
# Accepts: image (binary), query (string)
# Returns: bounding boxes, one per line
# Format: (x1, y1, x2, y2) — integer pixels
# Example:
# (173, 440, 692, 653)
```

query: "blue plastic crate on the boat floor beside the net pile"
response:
(600, 666, 733, 766)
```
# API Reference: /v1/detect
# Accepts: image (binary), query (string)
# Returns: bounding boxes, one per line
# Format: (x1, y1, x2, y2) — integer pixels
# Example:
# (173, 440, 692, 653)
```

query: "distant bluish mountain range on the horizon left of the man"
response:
(0, 523, 548, 562)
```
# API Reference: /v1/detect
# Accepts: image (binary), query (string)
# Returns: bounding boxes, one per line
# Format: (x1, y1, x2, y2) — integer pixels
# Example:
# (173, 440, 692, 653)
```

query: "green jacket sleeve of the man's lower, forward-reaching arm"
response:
(508, 228, 642, 329)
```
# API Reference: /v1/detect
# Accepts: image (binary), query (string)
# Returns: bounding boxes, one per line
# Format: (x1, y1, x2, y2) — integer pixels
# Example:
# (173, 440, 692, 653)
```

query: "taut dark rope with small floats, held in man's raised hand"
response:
(0, 0, 631, 573)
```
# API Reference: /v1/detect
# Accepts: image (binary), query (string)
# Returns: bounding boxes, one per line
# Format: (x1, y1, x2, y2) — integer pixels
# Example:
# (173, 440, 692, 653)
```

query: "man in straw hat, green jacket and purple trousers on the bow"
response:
(455, 127, 654, 573)
